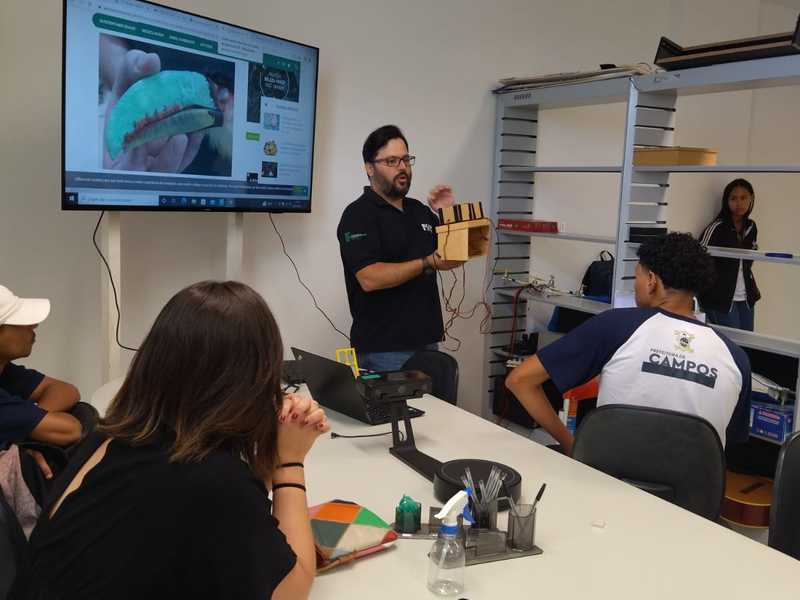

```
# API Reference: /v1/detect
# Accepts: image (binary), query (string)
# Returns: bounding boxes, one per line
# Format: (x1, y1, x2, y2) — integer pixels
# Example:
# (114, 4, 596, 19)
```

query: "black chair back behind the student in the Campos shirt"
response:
(572, 404, 725, 521)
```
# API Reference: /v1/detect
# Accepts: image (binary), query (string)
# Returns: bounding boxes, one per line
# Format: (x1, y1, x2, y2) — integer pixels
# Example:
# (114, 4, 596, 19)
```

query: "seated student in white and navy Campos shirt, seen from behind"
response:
(506, 233, 750, 454)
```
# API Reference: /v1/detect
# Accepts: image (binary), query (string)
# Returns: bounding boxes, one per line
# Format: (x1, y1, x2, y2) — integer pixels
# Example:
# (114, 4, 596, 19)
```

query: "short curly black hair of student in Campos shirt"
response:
(638, 233, 715, 295)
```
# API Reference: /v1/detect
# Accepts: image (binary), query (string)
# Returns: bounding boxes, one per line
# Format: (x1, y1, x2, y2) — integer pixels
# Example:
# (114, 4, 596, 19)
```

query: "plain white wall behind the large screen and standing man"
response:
(0, 0, 791, 418)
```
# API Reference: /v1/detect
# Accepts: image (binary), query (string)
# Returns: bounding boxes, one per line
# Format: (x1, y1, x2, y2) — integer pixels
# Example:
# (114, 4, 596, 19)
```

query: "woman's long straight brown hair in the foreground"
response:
(100, 281, 283, 478)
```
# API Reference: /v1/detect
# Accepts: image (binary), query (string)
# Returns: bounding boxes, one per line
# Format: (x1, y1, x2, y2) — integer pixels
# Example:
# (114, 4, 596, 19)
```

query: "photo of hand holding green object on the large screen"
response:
(99, 34, 235, 177)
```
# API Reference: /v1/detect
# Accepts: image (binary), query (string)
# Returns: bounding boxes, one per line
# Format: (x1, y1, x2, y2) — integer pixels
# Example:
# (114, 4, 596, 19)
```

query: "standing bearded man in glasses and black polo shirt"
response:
(337, 125, 463, 371)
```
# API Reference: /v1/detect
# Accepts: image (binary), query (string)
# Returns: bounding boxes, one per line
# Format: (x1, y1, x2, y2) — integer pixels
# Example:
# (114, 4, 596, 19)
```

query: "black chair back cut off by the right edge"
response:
(769, 432, 800, 560)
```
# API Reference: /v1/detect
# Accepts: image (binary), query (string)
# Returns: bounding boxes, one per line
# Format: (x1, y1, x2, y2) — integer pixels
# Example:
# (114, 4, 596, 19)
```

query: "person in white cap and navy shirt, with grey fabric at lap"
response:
(0, 285, 82, 535)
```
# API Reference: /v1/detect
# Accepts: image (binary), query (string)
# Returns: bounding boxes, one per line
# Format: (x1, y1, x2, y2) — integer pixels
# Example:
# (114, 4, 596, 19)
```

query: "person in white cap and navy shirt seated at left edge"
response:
(0, 285, 82, 478)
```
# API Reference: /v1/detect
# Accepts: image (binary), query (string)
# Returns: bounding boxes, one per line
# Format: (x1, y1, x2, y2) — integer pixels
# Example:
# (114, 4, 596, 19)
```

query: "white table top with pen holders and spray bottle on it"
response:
(306, 397, 800, 600)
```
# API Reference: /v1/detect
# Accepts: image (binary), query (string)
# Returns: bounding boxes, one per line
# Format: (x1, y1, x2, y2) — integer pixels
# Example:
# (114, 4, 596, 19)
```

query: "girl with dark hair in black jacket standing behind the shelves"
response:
(700, 179, 761, 331)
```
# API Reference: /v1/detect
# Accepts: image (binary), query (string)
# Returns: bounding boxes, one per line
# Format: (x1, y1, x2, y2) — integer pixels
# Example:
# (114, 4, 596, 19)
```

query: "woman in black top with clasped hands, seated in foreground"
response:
(30, 281, 330, 600)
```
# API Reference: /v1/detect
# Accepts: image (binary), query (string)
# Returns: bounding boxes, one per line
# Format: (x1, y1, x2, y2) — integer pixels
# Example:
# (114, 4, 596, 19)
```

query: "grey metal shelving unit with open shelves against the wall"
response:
(483, 56, 800, 429)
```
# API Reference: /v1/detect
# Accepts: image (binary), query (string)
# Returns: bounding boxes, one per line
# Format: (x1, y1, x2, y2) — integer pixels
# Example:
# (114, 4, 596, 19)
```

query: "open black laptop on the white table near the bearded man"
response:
(292, 348, 425, 425)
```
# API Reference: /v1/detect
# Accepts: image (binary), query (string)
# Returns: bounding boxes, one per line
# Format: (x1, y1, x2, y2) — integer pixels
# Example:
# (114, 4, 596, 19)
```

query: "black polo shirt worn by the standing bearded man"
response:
(336, 187, 444, 352)
